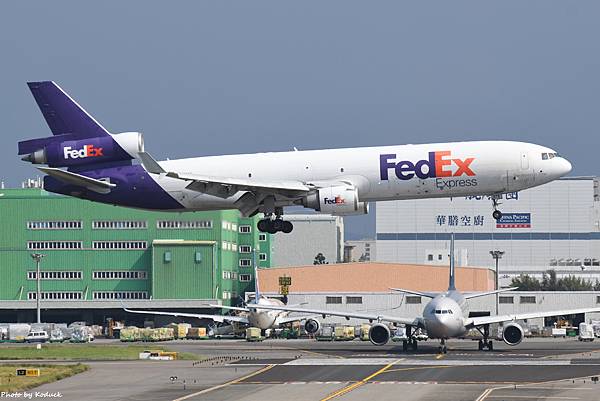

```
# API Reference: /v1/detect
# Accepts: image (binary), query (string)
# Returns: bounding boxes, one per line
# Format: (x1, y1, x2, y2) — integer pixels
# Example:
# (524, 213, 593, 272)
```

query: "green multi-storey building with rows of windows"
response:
(0, 188, 271, 323)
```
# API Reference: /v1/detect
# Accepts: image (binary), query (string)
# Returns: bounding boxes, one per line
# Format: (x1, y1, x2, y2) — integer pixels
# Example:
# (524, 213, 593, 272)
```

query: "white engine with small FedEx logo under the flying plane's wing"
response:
(302, 184, 369, 216)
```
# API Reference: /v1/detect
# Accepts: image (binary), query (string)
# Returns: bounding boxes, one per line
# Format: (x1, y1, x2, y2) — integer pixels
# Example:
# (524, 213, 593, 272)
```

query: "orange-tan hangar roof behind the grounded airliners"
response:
(258, 262, 495, 293)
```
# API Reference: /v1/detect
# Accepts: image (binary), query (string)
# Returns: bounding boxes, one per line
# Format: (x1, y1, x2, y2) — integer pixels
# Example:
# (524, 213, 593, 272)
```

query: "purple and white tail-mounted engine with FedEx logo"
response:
(19, 132, 144, 167)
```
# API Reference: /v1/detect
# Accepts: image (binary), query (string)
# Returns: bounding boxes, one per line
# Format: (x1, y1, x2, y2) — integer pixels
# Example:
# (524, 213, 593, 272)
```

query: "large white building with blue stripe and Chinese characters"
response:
(376, 178, 600, 285)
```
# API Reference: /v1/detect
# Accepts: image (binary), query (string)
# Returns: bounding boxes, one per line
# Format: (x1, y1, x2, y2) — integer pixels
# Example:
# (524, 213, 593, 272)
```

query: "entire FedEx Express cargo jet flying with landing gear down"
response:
(19, 81, 571, 234)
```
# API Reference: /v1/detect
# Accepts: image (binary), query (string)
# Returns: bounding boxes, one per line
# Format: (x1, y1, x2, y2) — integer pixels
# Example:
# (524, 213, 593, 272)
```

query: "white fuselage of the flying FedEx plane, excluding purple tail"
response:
(151, 141, 571, 210)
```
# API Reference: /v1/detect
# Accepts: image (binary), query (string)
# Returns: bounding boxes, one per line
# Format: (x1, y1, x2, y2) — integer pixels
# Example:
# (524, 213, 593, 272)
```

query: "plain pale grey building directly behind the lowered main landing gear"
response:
(271, 214, 344, 267)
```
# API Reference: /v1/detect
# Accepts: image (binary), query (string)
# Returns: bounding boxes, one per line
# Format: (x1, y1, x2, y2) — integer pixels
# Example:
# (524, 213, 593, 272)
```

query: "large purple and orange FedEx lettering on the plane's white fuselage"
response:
(379, 150, 475, 181)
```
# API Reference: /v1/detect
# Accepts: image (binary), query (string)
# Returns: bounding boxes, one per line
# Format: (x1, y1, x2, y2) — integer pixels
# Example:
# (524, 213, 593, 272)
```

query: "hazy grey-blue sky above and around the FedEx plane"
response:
(0, 0, 600, 237)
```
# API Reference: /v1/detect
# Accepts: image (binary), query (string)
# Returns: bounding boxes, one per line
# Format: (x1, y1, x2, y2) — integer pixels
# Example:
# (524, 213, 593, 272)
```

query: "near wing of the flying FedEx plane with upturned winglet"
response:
(138, 152, 312, 198)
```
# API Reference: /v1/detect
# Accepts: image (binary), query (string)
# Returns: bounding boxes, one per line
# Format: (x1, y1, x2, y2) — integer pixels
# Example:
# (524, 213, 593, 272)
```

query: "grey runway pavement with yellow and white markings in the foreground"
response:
(31, 339, 600, 401)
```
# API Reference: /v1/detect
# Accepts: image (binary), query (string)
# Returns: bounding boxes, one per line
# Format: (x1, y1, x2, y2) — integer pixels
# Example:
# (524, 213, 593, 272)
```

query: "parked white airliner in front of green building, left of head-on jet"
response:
(123, 263, 321, 334)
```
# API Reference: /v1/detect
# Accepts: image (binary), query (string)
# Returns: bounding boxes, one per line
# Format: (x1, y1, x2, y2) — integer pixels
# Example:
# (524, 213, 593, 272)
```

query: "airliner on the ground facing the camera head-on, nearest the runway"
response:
(253, 234, 600, 353)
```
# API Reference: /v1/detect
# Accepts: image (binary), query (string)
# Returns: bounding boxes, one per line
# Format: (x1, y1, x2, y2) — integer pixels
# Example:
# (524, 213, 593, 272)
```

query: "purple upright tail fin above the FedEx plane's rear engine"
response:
(27, 81, 109, 139)
